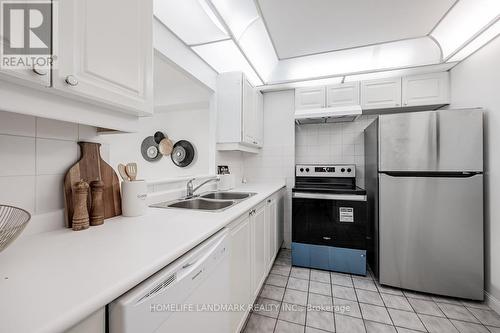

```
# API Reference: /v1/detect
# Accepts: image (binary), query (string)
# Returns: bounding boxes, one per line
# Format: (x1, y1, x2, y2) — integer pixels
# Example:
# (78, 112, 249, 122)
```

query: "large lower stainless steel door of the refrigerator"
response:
(379, 174, 483, 300)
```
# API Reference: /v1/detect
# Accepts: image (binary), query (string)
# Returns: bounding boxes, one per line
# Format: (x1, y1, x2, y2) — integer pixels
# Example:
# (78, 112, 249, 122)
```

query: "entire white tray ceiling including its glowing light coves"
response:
(155, 0, 500, 89)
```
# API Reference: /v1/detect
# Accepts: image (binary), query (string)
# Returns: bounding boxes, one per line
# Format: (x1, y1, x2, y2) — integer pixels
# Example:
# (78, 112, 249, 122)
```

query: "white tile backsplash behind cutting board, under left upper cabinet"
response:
(0, 111, 109, 215)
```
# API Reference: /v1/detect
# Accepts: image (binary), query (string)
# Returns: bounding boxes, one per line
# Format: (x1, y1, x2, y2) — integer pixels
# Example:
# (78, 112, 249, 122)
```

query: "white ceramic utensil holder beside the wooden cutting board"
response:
(122, 180, 148, 216)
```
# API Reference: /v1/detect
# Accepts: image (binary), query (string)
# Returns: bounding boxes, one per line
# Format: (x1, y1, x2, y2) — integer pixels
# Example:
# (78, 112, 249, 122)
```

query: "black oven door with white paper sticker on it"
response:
(292, 192, 368, 250)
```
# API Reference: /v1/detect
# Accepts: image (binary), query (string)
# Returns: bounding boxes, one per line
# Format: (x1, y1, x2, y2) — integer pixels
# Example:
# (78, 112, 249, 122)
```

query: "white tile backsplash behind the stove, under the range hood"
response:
(295, 116, 376, 187)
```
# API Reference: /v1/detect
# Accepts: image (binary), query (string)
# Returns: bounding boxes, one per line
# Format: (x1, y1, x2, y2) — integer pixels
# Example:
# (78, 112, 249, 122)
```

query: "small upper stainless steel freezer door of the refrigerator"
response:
(379, 110, 483, 172)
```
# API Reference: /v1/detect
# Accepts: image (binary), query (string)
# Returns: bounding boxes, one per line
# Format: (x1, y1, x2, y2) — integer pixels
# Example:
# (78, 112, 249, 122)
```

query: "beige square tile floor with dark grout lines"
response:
(243, 250, 500, 333)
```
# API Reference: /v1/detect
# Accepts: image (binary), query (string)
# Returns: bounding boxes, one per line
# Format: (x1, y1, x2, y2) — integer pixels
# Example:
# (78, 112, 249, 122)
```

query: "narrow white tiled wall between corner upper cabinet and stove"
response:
(244, 90, 295, 247)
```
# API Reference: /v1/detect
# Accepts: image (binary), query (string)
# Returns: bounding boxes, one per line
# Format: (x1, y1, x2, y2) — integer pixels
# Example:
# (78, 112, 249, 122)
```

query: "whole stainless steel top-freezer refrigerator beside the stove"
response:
(365, 109, 484, 300)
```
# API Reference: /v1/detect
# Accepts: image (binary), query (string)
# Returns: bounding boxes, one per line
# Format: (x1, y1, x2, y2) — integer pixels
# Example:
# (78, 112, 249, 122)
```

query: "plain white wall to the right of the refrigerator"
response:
(451, 38, 500, 311)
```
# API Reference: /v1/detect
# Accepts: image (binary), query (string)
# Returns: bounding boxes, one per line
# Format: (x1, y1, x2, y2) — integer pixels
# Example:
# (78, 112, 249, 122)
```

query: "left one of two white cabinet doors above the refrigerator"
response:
(361, 77, 401, 110)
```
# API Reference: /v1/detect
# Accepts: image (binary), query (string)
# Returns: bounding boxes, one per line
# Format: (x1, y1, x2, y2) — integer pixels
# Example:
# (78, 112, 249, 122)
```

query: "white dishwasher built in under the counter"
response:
(108, 229, 230, 333)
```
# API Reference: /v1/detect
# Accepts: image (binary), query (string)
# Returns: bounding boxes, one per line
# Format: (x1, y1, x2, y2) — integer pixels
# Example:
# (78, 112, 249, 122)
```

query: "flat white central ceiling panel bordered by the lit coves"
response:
(258, 0, 455, 59)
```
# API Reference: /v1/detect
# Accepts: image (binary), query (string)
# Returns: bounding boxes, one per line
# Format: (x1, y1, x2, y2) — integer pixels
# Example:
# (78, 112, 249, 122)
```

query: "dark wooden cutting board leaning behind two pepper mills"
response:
(64, 142, 122, 228)
